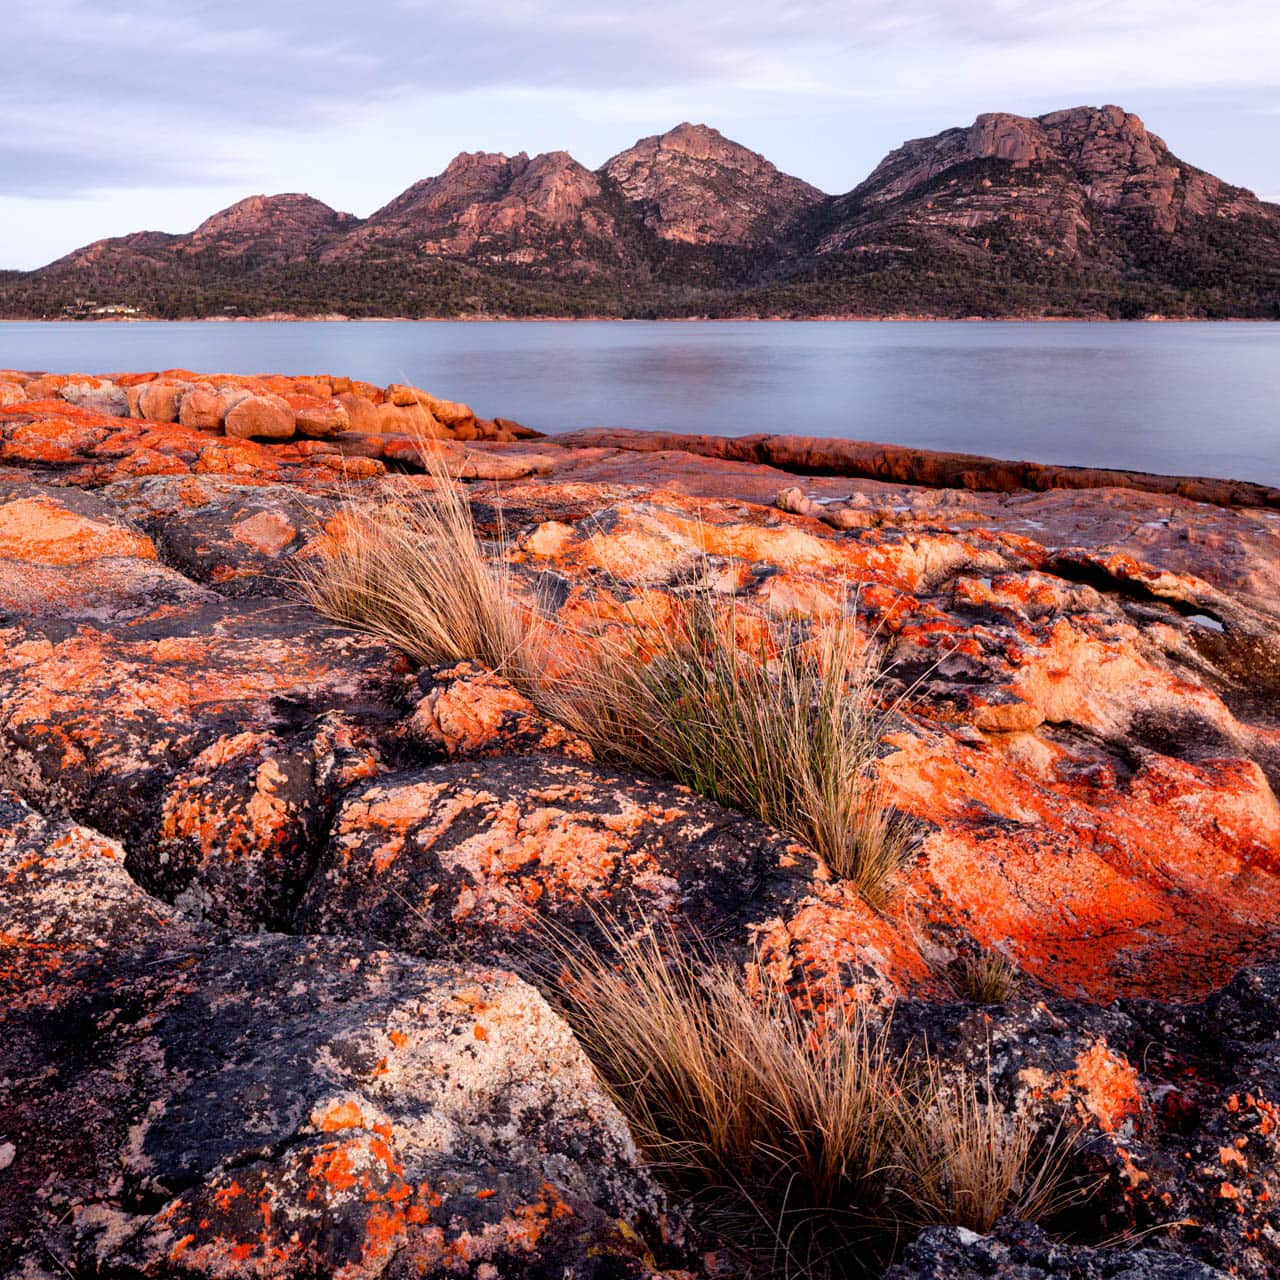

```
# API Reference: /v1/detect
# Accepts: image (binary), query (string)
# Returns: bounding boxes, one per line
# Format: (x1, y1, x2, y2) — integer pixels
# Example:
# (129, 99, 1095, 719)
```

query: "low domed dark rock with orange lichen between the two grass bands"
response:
(298, 756, 824, 959)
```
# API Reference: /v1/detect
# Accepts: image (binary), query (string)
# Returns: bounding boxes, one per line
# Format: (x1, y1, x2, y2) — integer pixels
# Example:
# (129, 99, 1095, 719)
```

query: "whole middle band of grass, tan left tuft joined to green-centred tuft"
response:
(300, 476, 914, 905)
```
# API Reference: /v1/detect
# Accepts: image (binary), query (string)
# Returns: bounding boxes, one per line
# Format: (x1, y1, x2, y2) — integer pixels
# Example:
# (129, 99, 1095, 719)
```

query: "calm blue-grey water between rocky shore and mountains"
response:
(0, 321, 1280, 484)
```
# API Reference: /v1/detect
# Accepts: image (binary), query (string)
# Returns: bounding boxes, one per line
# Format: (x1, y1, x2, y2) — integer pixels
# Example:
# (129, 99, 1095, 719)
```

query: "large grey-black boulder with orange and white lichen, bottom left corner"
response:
(0, 792, 668, 1280)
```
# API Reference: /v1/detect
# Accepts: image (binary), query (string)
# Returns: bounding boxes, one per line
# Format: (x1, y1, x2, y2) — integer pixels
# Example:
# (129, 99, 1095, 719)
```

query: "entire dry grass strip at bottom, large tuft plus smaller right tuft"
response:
(547, 925, 1069, 1277)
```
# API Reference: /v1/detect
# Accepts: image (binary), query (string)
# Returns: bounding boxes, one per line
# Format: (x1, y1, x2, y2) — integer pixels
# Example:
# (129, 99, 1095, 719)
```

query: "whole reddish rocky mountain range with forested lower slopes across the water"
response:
(0, 106, 1280, 319)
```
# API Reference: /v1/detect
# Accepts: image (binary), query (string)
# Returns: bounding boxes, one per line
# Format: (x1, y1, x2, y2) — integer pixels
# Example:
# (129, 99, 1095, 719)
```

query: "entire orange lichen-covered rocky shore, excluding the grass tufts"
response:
(0, 370, 1280, 1280)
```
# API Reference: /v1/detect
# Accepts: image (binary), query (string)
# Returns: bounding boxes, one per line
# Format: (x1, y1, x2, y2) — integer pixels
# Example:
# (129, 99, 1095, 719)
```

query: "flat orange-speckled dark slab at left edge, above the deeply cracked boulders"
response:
(0, 593, 401, 847)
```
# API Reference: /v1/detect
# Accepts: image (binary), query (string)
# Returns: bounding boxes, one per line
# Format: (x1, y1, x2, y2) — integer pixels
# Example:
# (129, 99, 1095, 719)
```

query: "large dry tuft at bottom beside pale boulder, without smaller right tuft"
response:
(553, 931, 905, 1275)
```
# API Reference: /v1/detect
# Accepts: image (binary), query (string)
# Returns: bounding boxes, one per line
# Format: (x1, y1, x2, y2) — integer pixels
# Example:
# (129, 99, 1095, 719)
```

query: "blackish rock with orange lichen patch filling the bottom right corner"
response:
(892, 963, 1280, 1280)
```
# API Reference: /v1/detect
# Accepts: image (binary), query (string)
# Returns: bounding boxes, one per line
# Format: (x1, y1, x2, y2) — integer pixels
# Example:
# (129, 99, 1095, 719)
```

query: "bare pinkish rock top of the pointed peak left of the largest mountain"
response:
(600, 122, 823, 244)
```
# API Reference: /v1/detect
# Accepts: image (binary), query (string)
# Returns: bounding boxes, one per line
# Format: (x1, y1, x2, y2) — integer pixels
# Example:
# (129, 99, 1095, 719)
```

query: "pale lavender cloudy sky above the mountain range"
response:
(0, 0, 1280, 269)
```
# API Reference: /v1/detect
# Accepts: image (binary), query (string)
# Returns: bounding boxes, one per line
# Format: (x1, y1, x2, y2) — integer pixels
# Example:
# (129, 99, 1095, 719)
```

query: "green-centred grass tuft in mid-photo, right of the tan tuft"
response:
(548, 580, 914, 905)
